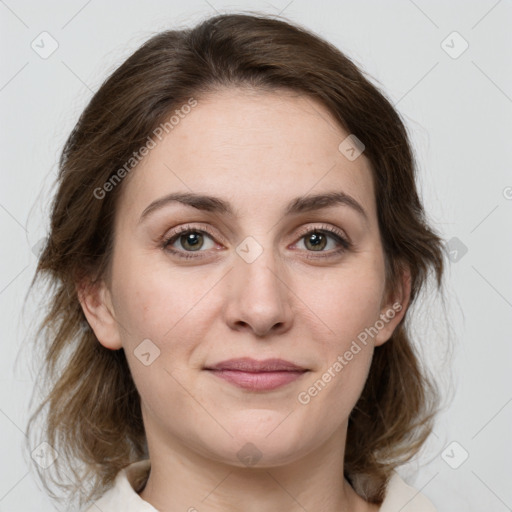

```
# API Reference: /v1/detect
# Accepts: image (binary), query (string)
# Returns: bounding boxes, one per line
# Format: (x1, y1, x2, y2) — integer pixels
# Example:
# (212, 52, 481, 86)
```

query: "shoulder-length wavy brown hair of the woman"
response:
(29, 13, 444, 503)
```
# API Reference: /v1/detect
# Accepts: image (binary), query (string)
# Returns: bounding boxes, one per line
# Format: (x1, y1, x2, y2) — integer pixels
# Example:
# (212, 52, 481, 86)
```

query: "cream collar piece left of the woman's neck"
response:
(80, 460, 157, 512)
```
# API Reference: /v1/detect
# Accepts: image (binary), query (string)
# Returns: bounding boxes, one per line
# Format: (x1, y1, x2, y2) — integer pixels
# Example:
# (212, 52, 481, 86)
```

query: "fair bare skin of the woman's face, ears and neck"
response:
(81, 89, 410, 512)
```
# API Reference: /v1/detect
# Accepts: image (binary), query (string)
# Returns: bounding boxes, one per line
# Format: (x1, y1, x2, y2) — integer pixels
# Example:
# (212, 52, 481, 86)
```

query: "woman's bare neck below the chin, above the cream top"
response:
(140, 420, 378, 512)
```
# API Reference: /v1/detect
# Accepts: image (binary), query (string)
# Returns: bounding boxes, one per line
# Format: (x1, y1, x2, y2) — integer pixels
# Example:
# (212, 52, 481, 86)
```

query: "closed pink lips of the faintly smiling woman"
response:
(205, 357, 309, 391)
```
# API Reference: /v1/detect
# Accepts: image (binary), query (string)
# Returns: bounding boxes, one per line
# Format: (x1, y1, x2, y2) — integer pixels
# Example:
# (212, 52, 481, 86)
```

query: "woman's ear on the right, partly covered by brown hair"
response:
(374, 267, 411, 347)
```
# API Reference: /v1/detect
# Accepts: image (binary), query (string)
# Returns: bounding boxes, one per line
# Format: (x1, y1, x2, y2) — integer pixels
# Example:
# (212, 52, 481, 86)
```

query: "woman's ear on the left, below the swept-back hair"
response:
(77, 280, 122, 350)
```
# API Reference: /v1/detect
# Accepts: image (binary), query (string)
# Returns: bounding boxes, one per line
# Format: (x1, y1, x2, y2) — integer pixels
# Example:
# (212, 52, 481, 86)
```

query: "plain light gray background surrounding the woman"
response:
(0, 0, 512, 512)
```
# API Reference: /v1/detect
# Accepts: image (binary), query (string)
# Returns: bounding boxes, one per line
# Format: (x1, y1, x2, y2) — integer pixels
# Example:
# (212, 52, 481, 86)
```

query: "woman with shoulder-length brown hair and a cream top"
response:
(27, 10, 444, 512)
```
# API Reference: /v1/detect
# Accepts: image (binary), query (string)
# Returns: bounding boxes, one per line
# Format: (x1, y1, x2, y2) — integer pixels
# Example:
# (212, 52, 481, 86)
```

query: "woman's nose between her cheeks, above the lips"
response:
(224, 243, 294, 337)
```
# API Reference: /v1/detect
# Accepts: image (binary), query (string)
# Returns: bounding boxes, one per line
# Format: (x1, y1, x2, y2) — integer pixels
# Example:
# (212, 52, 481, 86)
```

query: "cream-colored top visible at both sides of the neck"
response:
(86, 460, 436, 512)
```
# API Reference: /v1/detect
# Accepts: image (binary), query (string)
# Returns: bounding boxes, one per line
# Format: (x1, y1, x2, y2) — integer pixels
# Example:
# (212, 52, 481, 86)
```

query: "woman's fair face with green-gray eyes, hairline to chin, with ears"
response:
(83, 90, 405, 466)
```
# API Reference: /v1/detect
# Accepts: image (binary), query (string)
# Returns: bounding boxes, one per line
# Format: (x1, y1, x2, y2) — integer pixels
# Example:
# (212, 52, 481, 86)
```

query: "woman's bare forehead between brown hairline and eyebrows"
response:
(119, 89, 375, 222)
